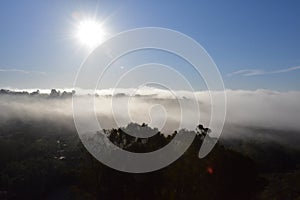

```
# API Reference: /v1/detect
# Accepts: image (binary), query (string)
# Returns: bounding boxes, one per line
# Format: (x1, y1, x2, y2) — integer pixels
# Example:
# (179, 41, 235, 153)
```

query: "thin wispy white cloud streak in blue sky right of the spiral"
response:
(226, 66, 300, 76)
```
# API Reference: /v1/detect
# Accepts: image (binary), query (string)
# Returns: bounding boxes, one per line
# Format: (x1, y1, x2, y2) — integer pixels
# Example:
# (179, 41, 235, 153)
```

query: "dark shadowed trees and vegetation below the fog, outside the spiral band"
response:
(0, 120, 300, 199)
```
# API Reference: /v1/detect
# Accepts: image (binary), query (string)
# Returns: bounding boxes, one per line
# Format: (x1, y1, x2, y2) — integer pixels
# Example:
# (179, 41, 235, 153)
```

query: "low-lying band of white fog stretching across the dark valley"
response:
(0, 88, 300, 148)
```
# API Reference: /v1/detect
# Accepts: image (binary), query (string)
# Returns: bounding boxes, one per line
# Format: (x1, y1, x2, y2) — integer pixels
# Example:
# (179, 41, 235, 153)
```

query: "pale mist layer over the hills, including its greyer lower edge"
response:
(0, 88, 300, 162)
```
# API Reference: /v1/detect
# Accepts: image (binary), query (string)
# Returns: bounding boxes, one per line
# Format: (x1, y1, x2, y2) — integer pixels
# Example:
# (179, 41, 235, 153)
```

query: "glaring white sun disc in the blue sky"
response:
(76, 20, 105, 48)
